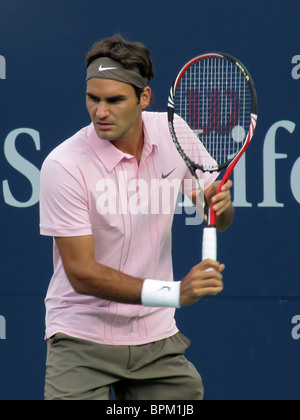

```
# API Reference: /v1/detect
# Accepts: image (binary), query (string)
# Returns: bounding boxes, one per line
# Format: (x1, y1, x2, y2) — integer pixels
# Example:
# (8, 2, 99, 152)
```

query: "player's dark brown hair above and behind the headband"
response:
(86, 34, 154, 103)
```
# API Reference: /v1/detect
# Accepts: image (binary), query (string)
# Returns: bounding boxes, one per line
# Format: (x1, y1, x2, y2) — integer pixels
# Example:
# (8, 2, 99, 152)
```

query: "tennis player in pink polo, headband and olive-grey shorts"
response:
(40, 35, 233, 400)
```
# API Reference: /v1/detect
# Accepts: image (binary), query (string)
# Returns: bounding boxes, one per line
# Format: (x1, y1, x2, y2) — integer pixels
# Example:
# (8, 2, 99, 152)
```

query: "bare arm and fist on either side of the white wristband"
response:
(55, 235, 224, 306)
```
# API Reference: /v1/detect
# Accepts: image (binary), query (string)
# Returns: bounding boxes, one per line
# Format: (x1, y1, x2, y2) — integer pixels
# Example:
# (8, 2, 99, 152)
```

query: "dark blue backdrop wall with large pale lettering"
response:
(0, 0, 300, 400)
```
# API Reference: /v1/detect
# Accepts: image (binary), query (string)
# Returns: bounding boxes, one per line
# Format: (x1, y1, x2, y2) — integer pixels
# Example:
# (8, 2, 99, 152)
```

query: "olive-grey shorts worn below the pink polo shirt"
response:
(45, 333, 203, 401)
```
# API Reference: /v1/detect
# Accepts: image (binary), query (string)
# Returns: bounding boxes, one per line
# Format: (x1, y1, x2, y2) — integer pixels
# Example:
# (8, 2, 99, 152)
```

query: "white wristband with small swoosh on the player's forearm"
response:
(141, 279, 181, 308)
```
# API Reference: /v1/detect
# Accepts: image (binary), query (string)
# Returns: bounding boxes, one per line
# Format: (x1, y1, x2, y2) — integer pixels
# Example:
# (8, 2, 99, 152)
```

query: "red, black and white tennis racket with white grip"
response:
(168, 53, 257, 260)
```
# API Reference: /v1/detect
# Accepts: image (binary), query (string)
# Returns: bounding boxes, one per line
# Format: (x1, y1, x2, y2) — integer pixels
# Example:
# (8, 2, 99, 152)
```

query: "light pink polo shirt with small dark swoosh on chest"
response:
(40, 112, 216, 345)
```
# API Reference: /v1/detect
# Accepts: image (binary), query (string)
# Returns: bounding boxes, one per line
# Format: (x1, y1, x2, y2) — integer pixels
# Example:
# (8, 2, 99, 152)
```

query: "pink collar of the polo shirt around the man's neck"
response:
(87, 113, 157, 172)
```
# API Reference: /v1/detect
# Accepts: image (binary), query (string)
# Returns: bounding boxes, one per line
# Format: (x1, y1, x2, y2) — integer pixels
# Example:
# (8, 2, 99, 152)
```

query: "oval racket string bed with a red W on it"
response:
(173, 57, 252, 166)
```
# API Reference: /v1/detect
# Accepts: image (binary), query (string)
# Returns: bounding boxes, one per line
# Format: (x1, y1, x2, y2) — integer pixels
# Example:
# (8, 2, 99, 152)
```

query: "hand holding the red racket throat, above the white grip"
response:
(205, 180, 234, 232)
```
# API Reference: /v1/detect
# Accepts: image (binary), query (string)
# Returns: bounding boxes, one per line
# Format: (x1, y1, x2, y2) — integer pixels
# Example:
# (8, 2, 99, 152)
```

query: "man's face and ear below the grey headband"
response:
(86, 79, 151, 141)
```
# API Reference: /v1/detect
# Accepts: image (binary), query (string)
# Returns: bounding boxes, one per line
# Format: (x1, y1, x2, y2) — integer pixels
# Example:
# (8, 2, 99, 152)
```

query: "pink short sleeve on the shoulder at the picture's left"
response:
(40, 158, 92, 237)
